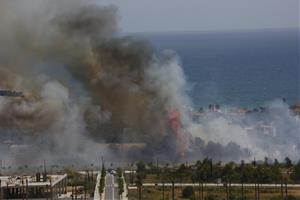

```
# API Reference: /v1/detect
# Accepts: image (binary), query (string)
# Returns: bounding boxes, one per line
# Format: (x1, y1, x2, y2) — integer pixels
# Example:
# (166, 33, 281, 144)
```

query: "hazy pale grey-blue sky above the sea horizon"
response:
(98, 0, 299, 32)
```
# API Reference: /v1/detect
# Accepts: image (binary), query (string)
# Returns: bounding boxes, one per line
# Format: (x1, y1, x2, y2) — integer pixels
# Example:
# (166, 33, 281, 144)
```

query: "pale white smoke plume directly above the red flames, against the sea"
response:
(146, 50, 192, 123)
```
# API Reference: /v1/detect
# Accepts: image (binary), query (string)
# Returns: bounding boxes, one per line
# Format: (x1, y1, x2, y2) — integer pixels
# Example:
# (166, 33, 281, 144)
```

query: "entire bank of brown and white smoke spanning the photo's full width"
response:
(0, 0, 300, 166)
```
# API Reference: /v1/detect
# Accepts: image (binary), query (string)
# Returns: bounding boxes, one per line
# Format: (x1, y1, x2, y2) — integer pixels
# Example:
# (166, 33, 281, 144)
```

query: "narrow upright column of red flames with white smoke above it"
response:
(146, 50, 192, 156)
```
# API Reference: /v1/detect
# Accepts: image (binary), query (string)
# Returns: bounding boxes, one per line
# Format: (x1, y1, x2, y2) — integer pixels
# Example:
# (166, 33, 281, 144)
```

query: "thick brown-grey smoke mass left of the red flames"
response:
(0, 1, 188, 166)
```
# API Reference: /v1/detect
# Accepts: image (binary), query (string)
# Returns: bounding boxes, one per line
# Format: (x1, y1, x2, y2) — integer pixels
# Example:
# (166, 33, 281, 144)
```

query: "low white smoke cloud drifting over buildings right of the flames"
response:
(189, 100, 300, 161)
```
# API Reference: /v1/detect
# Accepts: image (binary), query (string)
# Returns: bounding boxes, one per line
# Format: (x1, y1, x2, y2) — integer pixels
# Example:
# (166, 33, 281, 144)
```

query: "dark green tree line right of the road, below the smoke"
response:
(136, 157, 300, 184)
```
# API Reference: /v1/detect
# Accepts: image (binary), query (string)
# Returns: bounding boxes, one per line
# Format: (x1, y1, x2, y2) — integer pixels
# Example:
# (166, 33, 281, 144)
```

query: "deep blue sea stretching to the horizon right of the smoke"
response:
(138, 29, 300, 107)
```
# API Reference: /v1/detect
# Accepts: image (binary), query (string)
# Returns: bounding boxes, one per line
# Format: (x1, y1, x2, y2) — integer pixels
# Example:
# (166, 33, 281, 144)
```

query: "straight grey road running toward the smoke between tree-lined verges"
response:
(104, 173, 119, 200)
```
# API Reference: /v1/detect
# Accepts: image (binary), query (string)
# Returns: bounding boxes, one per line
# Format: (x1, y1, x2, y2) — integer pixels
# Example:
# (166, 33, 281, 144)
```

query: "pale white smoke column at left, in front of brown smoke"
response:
(42, 82, 112, 162)
